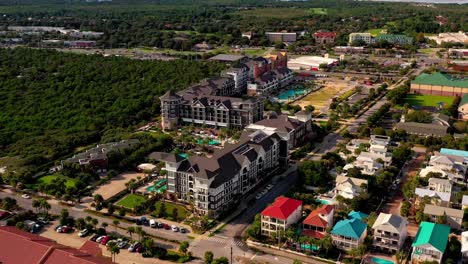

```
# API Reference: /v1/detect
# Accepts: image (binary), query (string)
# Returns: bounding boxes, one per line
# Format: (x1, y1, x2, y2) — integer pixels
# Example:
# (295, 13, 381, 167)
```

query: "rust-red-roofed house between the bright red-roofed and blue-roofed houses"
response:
(302, 204, 335, 239)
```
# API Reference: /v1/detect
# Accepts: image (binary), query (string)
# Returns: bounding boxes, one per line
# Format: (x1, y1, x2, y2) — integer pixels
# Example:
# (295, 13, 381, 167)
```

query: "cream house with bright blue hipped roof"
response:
(330, 218, 367, 250)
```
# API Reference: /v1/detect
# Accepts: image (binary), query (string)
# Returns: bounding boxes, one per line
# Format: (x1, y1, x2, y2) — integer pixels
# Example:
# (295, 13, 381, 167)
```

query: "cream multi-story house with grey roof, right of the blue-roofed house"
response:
(372, 213, 408, 254)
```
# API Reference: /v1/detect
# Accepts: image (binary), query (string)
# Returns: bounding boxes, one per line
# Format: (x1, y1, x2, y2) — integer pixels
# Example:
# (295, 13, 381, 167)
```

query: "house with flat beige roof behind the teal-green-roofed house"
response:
(424, 204, 464, 230)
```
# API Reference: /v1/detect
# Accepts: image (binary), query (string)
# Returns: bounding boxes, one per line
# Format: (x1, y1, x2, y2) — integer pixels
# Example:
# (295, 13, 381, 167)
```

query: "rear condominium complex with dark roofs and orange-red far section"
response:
(159, 52, 293, 130)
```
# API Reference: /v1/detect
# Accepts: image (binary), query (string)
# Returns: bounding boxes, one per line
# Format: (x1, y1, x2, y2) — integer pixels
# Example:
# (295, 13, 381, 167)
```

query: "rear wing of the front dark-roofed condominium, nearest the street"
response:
(245, 111, 316, 148)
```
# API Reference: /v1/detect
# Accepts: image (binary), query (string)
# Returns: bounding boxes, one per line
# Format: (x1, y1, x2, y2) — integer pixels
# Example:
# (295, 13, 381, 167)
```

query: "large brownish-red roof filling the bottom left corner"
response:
(0, 226, 113, 264)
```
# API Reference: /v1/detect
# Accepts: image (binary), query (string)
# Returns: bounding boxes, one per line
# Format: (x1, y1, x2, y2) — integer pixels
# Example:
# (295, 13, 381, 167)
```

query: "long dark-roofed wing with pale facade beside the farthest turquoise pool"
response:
(247, 68, 294, 96)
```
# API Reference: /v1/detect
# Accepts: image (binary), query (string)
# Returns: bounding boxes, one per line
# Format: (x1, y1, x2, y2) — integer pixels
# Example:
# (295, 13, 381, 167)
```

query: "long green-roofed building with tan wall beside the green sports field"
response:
(411, 72, 468, 96)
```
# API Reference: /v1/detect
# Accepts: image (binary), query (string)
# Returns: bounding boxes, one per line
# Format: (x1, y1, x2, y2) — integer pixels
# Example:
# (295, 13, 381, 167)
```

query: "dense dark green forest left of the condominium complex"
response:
(0, 48, 224, 168)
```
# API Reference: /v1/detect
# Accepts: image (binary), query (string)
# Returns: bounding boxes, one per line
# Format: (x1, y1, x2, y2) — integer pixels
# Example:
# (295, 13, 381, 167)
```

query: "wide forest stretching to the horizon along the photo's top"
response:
(0, 0, 468, 50)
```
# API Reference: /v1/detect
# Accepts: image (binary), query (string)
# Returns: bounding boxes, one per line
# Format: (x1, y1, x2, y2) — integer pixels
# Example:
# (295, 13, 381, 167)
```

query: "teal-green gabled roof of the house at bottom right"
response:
(412, 222, 450, 253)
